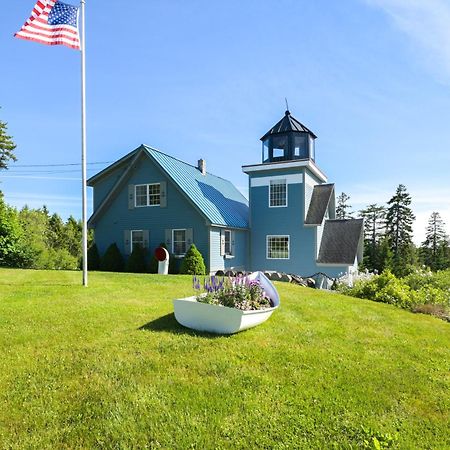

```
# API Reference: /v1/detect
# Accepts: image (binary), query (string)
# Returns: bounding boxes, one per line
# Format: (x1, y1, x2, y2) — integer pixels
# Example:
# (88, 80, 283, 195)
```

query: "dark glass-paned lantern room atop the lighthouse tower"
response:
(261, 110, 317, 163)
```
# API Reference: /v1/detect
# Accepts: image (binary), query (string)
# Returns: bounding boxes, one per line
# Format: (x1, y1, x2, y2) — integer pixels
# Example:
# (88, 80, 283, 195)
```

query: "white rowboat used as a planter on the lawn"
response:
(173, 272, 280, 334)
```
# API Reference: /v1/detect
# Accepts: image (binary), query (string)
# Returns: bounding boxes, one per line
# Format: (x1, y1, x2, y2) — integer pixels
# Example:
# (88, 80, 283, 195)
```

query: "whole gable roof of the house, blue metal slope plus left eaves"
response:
(88, 145, 249, 228)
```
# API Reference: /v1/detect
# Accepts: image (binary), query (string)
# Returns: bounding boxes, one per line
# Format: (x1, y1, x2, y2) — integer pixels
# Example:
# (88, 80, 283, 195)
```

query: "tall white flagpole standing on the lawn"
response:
(81, 0, 88, 286)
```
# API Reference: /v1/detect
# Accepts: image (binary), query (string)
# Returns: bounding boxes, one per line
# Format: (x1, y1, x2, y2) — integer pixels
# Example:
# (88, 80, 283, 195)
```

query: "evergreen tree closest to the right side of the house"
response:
(360, 203, 386, 271)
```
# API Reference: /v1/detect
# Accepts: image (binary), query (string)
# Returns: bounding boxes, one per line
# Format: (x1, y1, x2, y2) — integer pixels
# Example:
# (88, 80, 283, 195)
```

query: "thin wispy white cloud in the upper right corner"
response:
(364, 0, 450, 84)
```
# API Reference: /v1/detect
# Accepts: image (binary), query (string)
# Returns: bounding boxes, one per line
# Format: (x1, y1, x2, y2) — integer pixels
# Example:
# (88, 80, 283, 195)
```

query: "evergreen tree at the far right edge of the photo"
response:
(420, 212, 450, 270)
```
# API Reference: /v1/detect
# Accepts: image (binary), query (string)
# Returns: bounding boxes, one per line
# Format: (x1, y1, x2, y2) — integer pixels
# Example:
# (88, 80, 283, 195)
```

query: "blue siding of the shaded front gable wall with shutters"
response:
(94, 157, 209, 264)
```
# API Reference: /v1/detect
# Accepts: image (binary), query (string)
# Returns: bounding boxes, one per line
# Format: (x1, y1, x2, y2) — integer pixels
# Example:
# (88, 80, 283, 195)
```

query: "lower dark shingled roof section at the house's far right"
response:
(317, 219, 364, 265)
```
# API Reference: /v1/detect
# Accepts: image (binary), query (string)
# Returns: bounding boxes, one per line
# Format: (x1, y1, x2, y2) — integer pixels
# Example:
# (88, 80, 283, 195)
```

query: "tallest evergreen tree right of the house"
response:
(386, 184, 417, 276)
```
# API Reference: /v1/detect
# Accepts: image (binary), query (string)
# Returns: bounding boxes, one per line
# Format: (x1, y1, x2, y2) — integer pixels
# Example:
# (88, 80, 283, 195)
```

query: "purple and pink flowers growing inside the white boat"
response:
(193, 276, 273, 311)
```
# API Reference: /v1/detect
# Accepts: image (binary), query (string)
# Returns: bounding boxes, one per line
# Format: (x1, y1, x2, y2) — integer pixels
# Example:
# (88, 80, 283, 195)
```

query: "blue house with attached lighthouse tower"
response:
(88, 111, 363, 276)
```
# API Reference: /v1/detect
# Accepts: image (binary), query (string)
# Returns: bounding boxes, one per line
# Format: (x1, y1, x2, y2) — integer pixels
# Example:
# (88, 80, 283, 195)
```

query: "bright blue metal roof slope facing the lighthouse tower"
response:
(143, 146, 249, 228)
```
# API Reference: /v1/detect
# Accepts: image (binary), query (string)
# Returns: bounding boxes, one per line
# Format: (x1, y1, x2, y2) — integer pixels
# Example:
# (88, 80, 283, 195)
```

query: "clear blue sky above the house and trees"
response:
(0, 0, 450, 242)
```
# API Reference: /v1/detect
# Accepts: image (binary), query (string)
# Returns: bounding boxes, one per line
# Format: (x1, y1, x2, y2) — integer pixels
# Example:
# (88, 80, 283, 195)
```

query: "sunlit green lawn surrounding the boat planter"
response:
(0, 269, 450, 449)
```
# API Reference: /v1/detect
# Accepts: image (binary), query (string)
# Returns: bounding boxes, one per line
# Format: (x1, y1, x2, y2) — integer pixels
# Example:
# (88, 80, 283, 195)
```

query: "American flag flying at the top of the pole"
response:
(14, 0, 80, 50)
